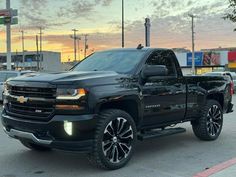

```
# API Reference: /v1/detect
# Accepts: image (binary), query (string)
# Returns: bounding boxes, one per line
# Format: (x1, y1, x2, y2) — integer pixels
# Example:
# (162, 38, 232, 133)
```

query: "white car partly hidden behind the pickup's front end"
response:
(0, 71, 33, 101)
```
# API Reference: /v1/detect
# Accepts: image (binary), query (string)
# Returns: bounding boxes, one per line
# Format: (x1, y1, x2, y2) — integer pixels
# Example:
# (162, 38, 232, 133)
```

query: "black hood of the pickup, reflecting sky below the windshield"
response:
(10, 71, 124, 85)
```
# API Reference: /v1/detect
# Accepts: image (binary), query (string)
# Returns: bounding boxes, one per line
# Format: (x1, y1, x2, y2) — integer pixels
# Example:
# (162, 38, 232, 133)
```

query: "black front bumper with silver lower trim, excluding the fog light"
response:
(2, 111, 96, 152)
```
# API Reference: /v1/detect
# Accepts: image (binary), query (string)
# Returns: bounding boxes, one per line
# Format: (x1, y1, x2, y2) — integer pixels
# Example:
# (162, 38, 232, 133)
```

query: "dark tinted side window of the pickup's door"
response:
(146, 51, 176, 76)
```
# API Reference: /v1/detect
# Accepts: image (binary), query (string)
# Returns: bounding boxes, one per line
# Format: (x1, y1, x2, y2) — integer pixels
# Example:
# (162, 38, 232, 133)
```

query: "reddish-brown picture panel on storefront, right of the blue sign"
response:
(203, 52, 220, 66)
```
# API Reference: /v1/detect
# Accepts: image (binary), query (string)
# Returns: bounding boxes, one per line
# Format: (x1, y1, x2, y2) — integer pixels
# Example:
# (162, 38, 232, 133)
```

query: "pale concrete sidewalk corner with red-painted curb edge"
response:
(193, 158, 236, 177)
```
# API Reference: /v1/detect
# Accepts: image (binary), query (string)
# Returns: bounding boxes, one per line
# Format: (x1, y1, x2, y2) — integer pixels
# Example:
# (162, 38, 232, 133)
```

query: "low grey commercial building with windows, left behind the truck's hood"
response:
(0, 51, 62, 72)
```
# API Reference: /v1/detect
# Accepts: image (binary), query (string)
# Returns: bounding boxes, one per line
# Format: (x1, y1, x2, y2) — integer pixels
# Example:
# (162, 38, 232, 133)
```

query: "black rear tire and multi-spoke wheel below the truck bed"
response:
(192, 100, 223, 141)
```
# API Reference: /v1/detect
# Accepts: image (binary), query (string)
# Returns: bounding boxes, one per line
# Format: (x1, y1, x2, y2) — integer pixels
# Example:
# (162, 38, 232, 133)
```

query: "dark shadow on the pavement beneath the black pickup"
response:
(0, 128, 221, 177)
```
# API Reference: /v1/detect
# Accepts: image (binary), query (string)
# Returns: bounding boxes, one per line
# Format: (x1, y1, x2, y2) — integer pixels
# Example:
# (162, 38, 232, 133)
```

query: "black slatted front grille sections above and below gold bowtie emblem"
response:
(6, 86, 56, 121)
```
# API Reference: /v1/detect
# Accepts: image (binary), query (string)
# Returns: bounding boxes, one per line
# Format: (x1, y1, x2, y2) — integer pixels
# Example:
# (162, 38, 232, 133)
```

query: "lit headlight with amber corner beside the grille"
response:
(57, 89, 86, 100)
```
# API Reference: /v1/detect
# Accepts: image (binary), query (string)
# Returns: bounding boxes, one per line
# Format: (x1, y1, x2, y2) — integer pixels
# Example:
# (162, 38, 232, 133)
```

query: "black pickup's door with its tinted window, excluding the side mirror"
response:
(142, 50, 186, 126)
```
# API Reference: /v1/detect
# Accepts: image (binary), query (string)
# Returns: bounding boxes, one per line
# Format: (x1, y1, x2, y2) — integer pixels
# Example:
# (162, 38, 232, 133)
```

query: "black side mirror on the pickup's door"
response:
(142, 65, 168, 78)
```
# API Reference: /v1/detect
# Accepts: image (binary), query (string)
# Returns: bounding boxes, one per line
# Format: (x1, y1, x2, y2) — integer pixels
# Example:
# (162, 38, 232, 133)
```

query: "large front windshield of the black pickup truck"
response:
(74, 50, 145, 74)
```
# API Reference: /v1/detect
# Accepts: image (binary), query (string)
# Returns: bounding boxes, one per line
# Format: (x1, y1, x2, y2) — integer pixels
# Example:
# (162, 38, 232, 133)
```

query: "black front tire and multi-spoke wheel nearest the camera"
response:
(88, 109, 137, 170)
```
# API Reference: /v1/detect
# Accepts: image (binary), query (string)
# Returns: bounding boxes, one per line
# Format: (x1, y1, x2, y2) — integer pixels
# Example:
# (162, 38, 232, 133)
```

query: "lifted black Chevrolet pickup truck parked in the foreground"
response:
(1, 47, 233, 170)
